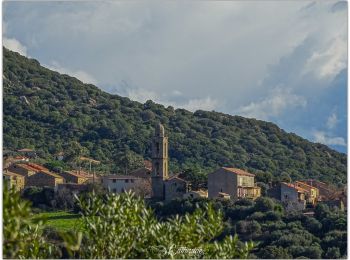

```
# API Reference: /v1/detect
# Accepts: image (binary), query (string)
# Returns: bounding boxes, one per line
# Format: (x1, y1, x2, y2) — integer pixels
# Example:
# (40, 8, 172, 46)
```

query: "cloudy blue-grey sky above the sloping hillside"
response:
(3, 0, 348, 152)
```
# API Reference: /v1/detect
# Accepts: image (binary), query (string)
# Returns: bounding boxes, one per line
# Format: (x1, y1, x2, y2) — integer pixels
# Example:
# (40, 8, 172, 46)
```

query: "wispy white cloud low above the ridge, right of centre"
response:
(237, 88, 307, 120)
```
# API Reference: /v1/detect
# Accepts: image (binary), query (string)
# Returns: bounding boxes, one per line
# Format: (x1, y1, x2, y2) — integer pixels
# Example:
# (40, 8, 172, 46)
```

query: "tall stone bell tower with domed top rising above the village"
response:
(152, 124, 168, 199)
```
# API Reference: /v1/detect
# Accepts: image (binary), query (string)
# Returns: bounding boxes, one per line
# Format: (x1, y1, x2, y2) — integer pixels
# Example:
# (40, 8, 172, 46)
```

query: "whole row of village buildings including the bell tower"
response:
(3, 124, 346, 211)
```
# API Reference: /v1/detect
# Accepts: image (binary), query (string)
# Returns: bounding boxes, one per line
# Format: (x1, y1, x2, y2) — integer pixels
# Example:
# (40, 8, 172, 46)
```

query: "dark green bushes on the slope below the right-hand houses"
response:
(150, 197, 347, 259)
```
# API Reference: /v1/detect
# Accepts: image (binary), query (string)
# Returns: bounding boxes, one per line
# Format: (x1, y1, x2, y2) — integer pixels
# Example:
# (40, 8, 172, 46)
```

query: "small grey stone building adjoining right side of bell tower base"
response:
(164, 175, 189, 201)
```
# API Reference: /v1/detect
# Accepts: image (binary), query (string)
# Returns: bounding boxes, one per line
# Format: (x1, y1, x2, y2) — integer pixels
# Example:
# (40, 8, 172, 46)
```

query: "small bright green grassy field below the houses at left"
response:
(33, 211, 80, 231)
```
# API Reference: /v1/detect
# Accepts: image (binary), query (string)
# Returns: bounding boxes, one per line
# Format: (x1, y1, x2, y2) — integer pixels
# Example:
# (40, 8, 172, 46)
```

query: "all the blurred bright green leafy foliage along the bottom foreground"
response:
(3, 186, 254, 259)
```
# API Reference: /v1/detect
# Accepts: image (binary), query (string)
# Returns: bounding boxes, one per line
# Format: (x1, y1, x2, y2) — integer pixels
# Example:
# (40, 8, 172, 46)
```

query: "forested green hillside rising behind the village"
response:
(3, 49, 346, 184)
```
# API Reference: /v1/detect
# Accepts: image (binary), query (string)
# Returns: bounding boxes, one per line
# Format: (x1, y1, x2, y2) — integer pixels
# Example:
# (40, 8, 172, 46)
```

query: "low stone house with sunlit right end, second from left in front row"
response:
(26, 171, 64, 187)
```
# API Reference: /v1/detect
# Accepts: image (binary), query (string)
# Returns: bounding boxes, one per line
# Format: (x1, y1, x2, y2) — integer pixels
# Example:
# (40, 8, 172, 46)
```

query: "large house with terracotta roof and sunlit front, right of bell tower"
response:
(208, 167, 261, 200)
